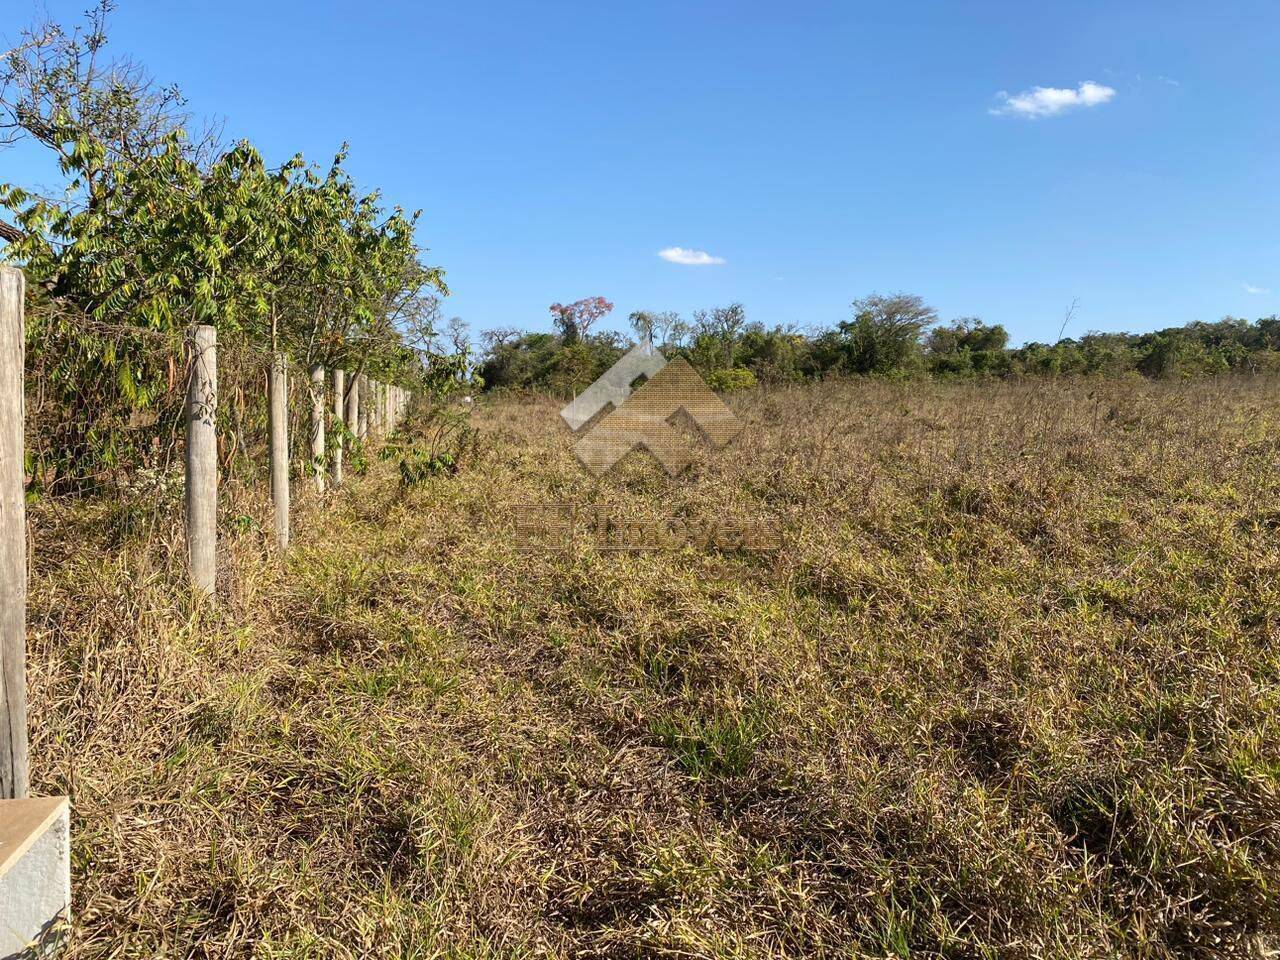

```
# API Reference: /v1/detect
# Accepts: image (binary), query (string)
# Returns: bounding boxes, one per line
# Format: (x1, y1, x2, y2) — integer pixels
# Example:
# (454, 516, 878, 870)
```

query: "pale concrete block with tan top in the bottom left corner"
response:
(0, 796, 72, 960)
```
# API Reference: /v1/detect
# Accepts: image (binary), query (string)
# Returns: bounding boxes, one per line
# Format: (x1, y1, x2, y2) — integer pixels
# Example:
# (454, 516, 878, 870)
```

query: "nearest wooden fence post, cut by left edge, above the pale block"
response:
(0, 266, 29, 800)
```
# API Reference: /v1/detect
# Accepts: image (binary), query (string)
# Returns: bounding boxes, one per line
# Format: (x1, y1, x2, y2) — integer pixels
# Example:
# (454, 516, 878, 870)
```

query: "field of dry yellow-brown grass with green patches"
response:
(29, 379, 1280, 957)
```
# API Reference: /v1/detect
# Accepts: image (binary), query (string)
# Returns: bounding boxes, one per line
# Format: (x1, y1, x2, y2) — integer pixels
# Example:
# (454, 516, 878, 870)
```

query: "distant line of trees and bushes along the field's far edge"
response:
(477, 293, 1280, 394)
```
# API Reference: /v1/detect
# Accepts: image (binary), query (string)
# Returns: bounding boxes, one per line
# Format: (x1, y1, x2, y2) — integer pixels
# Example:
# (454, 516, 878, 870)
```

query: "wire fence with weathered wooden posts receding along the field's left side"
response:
(0, 266, 410, 797)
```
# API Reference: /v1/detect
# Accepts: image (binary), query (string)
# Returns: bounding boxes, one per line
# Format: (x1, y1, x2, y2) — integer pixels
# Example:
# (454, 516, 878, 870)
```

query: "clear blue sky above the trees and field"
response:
(0, 0, 1280, 342)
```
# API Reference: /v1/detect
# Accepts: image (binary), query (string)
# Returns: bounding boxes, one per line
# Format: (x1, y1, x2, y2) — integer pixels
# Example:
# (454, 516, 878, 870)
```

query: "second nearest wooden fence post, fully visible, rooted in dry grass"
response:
(186, 324, 218, 596)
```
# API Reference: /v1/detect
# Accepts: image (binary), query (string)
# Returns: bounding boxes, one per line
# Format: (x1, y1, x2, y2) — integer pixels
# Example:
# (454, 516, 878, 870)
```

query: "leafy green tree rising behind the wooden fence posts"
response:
(0, 4, 447, 488)
